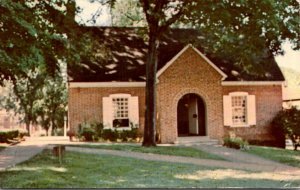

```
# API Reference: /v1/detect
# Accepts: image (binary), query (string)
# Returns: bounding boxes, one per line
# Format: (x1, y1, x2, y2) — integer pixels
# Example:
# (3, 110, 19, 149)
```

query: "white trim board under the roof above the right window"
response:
(221, 81, 284, 86)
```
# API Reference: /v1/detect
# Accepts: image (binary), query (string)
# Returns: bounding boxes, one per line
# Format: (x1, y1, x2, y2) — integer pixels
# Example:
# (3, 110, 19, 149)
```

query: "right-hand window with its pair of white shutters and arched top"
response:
(223, 92, 256, 127)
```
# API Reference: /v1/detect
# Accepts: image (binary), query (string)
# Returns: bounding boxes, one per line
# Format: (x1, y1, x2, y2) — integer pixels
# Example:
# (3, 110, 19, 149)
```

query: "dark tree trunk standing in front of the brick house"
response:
(143, 32, 158, 146)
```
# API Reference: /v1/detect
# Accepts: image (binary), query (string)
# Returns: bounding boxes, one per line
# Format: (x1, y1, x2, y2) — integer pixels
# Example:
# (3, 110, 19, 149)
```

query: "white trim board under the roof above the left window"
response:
(69, 82, 146, 88)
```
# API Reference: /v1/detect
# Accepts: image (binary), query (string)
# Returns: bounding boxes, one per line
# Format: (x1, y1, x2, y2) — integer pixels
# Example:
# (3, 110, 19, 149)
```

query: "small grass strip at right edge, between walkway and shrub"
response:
(247, 146, 300, 168)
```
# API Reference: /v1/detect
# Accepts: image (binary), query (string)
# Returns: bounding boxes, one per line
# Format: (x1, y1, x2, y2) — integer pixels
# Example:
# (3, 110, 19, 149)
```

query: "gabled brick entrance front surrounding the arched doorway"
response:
(157, 48, 223, 143)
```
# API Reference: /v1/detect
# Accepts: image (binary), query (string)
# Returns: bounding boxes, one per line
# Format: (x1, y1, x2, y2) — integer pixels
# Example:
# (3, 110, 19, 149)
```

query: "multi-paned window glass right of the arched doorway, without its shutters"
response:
(231, 96, 247, 125)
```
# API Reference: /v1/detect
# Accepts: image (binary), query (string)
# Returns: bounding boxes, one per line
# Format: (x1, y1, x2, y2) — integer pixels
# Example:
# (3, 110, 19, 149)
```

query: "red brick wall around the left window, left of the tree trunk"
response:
(69, 87, 145, 131)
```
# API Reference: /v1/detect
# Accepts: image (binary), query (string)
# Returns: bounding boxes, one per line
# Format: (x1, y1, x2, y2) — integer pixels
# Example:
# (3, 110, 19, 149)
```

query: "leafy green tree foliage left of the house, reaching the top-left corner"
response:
(0, 0, 89, 135)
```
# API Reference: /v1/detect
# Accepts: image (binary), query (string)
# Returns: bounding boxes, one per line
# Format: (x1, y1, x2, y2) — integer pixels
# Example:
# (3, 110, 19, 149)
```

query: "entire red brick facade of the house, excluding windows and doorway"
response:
(69, 48, 282, 143)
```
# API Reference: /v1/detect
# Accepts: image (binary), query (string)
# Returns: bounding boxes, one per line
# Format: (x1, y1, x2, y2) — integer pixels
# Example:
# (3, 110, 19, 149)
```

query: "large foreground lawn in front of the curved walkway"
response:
(0, 150, 300, 188)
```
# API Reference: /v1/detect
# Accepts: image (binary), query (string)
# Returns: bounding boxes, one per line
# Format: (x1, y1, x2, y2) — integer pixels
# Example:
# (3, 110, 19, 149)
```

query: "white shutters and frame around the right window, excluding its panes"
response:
(223, 92, 256, 127)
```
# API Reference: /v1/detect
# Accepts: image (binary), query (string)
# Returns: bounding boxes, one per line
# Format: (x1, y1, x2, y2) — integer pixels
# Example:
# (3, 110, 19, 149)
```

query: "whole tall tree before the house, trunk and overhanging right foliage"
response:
(90, 0, 300, 146)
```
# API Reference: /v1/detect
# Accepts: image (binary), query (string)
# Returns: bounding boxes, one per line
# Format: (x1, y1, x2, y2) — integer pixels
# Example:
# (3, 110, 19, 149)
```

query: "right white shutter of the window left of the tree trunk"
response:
(128, 96, 139, 126)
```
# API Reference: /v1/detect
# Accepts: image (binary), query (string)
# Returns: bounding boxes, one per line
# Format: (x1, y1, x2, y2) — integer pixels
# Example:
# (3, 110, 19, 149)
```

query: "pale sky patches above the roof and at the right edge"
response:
(76, 0, 300, 72)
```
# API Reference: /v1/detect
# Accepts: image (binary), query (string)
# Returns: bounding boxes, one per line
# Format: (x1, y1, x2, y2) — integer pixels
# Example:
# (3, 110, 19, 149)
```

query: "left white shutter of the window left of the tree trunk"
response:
(102, 97, 113, 128)
